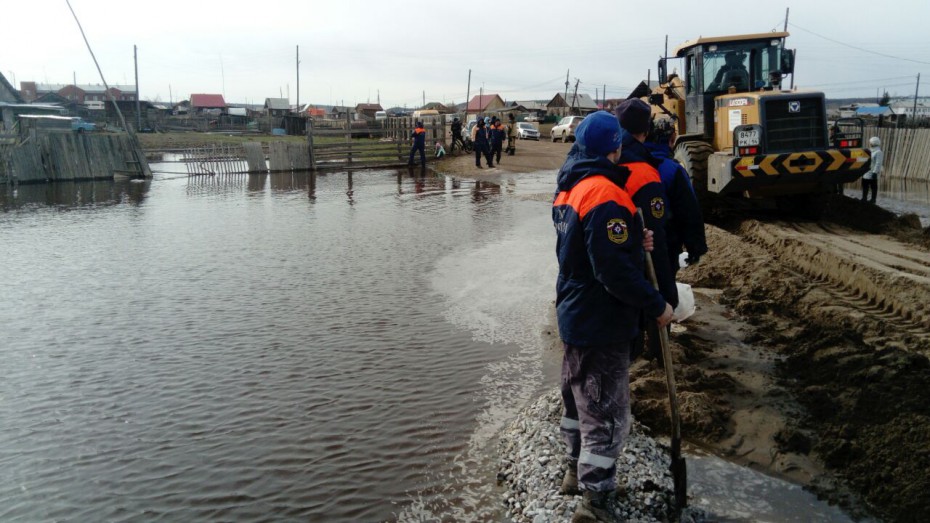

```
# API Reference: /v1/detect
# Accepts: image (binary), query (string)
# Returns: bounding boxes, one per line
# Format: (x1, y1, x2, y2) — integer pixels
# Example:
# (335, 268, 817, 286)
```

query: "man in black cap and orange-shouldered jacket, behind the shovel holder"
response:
(616, 98, 678, 363)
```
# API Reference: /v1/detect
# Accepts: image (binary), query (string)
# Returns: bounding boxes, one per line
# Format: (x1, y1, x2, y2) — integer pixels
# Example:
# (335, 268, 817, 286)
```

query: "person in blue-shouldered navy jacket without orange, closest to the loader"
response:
(645, 117, 707, 279)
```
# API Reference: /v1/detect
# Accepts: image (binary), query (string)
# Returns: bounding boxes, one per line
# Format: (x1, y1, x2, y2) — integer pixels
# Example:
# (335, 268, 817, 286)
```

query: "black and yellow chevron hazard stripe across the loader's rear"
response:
(733, 149, 869, 178)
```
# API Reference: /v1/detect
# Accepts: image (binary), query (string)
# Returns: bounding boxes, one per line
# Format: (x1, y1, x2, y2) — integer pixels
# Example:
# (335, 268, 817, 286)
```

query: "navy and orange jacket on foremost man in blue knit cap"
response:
(552, 143, 665, 347)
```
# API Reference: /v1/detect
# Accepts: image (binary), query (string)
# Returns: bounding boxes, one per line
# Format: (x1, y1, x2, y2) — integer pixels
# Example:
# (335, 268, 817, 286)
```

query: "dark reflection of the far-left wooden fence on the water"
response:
(0, 179, 152, 211)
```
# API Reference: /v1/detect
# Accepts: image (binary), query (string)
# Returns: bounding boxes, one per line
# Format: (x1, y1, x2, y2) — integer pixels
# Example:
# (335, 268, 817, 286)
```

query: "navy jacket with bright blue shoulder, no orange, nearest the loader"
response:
(645, 142, 707, 263)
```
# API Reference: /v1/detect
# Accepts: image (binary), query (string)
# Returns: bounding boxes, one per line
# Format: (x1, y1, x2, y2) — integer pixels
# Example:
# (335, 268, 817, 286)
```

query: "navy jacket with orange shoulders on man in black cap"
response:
(620, 133, 678, 307)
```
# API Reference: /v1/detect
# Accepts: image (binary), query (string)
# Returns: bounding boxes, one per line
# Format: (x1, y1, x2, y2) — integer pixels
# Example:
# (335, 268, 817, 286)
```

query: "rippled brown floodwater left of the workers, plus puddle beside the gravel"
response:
(0, 164, 872, 521)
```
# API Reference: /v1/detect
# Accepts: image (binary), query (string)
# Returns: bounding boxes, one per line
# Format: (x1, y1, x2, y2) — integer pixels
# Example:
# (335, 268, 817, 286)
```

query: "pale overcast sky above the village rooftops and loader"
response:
(0, 0, 930, 108)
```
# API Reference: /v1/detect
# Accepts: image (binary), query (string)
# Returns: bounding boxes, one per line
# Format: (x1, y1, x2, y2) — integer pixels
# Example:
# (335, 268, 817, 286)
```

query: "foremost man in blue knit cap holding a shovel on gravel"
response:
(552, 111, 672, 523)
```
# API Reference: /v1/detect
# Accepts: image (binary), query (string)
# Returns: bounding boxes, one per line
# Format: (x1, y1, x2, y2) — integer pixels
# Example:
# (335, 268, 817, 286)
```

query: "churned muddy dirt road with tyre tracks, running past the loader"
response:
(435, 142, 930, 521)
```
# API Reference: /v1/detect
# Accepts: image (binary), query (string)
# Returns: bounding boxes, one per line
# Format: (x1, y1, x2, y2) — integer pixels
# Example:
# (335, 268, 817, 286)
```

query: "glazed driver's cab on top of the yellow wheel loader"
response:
(659, 32, 794, 140)
